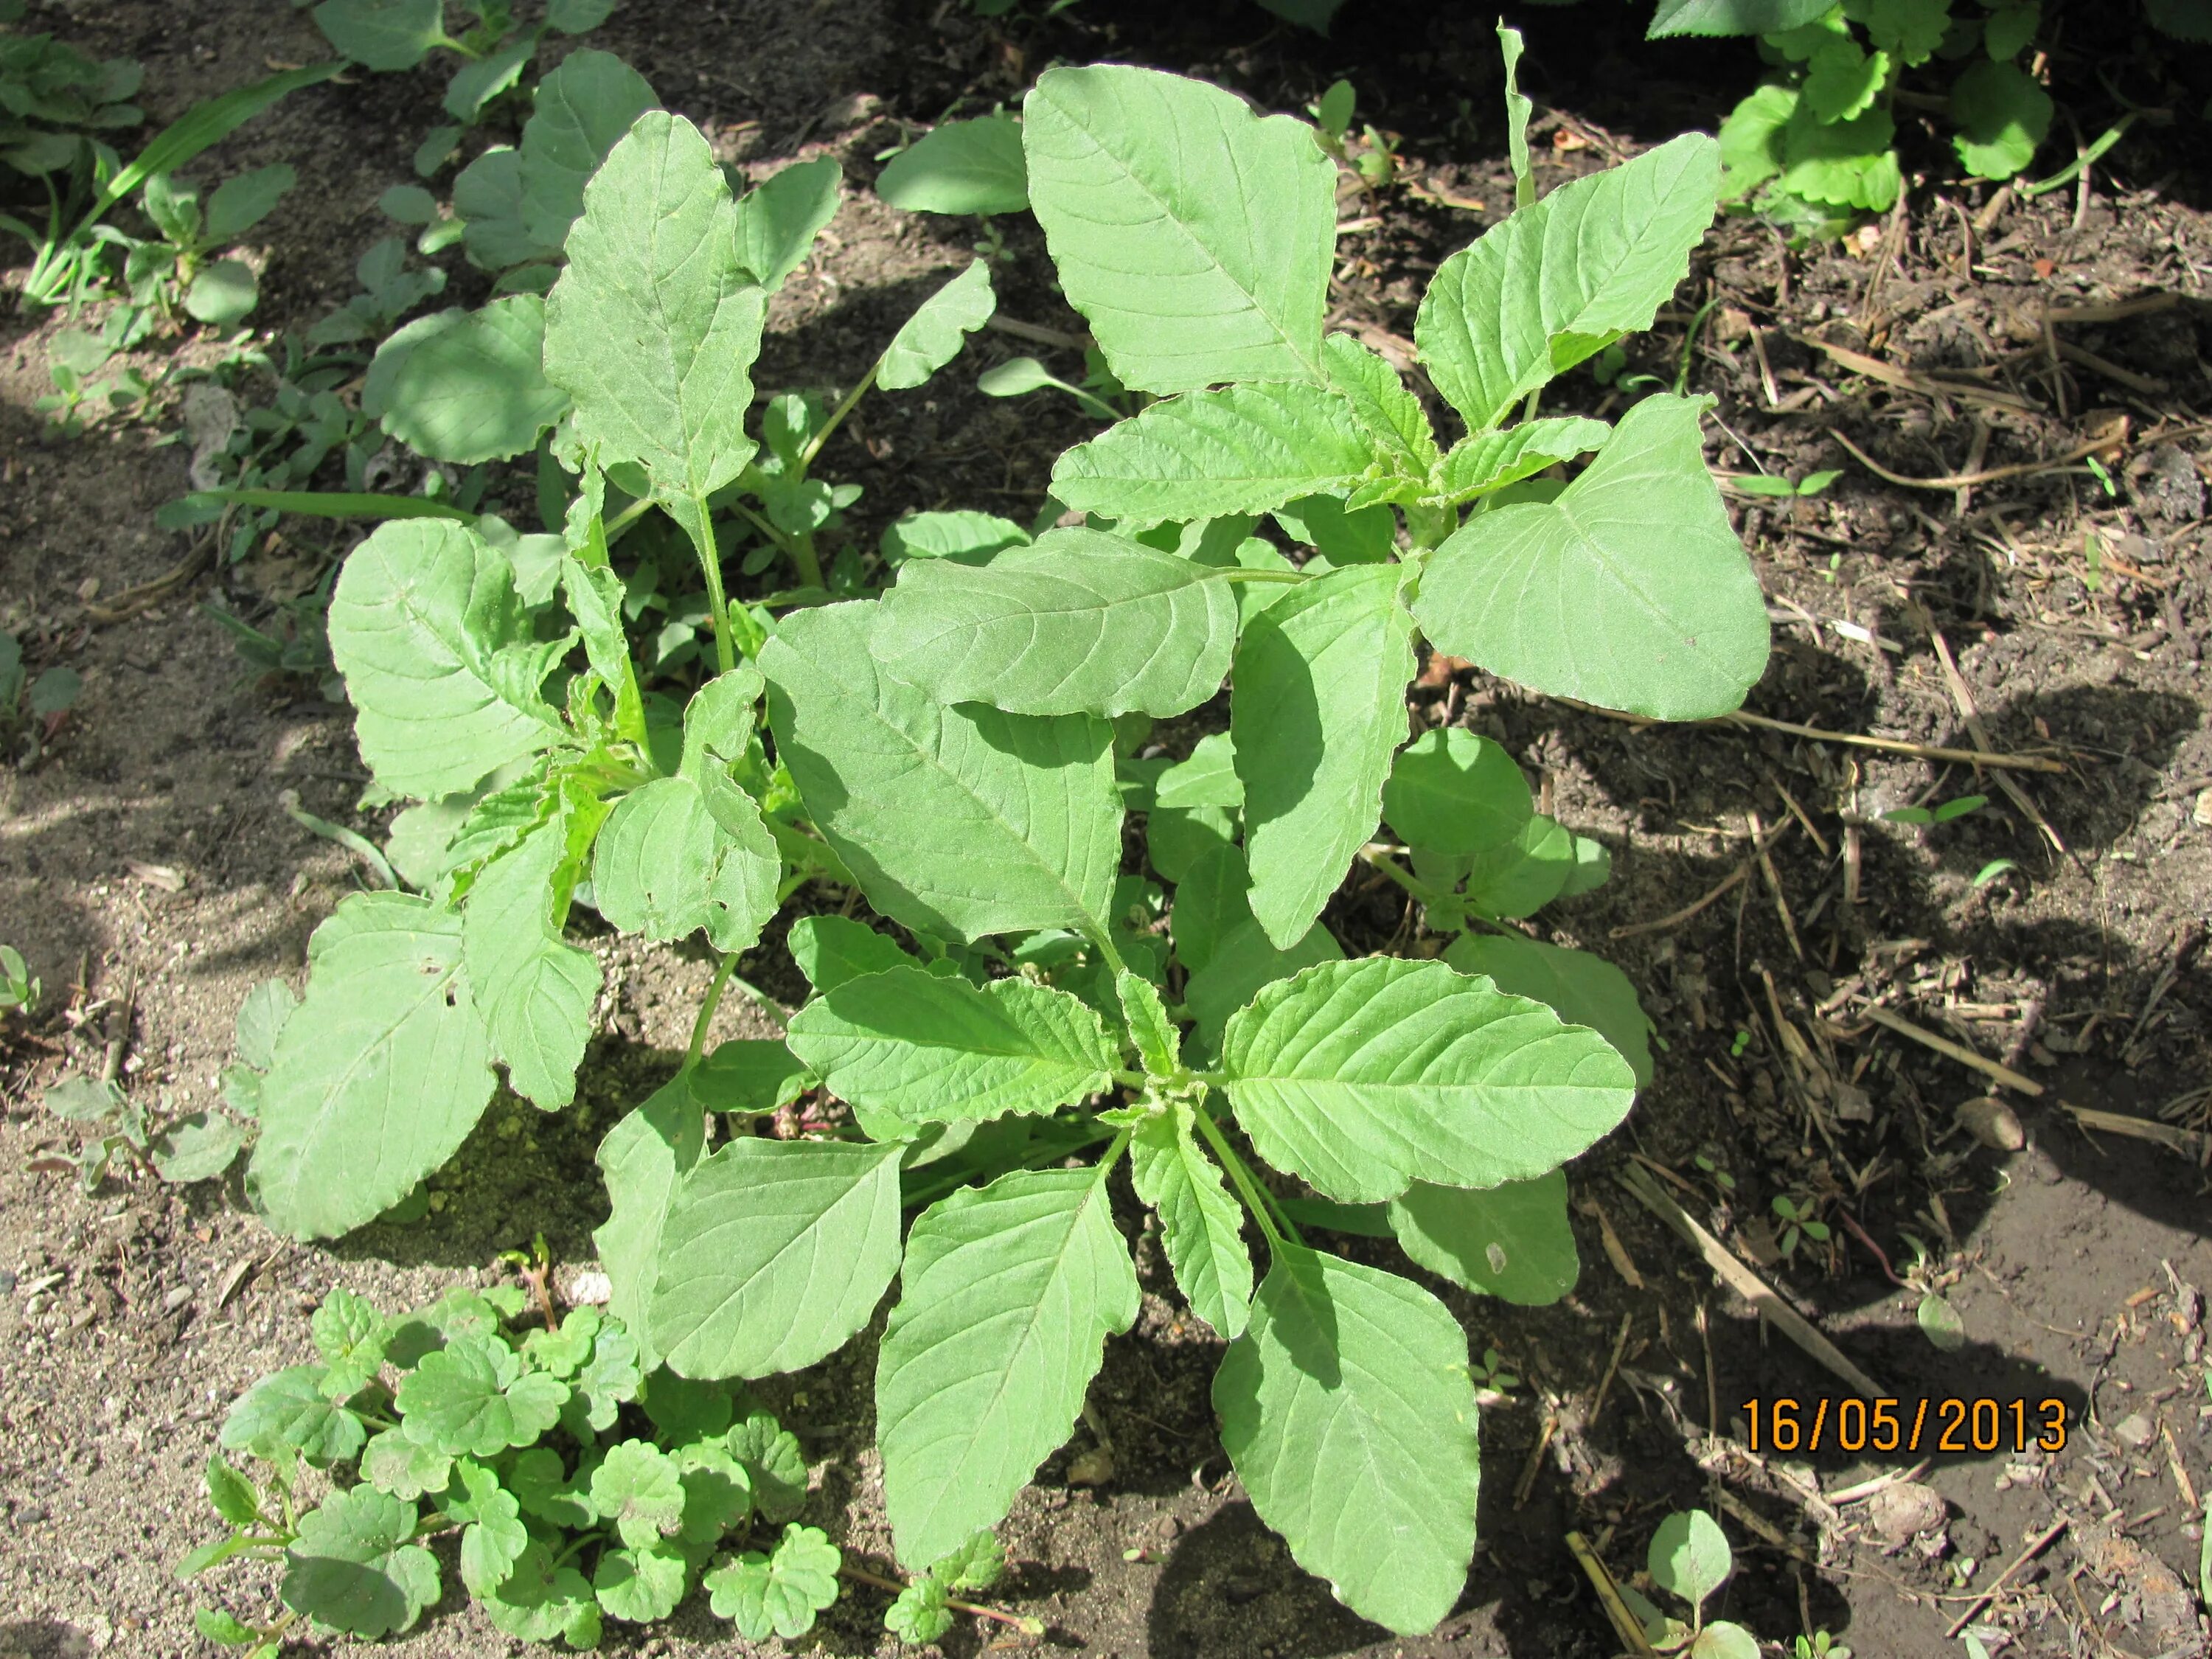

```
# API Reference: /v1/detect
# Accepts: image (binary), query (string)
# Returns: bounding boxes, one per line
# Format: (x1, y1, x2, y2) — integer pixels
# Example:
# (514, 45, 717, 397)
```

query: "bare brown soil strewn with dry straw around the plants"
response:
(0, 0, 2212, 1659)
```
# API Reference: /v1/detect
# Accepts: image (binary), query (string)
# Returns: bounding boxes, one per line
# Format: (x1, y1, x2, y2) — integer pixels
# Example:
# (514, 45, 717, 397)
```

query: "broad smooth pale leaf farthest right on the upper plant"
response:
(1413, 394, 1770, 721)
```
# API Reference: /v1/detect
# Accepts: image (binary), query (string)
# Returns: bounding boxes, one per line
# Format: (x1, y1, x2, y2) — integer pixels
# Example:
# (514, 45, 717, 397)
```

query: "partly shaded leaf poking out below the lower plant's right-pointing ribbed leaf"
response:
(1389, 1170, 1582, 1307)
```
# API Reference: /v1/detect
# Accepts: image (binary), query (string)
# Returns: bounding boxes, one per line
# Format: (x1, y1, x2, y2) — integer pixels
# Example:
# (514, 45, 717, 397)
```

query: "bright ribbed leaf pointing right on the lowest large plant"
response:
(1221, 956, 1635, 1203)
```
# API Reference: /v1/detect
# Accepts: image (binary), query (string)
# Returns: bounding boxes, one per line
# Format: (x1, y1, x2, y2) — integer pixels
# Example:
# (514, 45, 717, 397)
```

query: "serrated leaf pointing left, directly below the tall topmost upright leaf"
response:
(1051, 385, 1376, 524)
